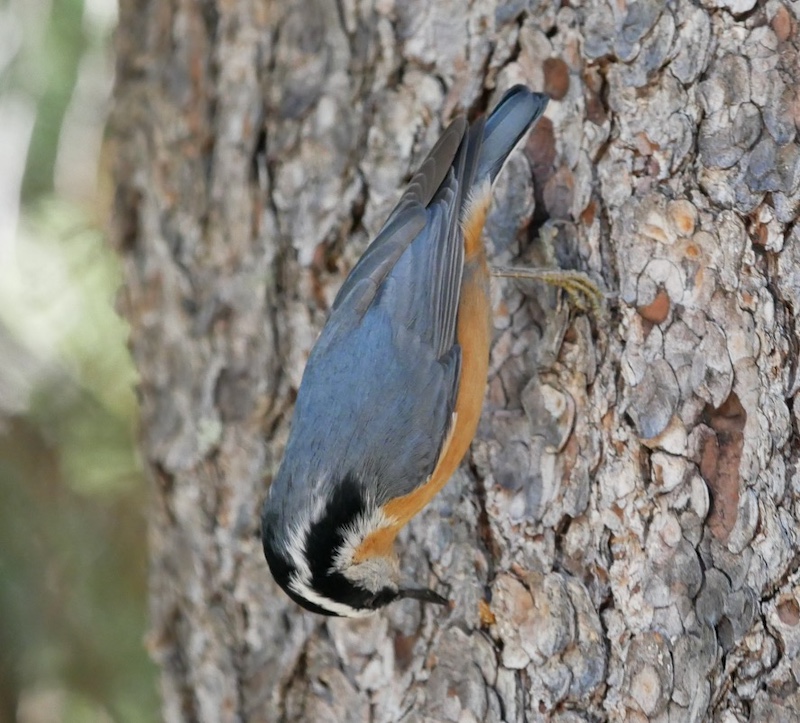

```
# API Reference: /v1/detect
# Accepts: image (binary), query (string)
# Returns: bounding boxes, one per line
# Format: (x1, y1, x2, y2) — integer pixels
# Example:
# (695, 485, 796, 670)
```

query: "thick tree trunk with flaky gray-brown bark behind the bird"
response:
(113, 0, 800, 723)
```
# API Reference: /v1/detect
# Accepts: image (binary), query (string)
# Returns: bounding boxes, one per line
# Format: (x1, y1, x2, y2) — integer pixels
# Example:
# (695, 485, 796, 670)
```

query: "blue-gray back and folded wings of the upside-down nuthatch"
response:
(284, 119, 476, 504)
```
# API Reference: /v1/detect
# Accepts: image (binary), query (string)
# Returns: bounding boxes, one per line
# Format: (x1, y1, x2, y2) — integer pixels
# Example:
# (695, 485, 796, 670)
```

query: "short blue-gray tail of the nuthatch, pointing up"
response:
(475, 85, 550, 182)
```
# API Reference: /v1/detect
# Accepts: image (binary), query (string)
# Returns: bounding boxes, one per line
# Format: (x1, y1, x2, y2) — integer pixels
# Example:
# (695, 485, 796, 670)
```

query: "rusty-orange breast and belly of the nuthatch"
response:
(354, 188, 492, 563)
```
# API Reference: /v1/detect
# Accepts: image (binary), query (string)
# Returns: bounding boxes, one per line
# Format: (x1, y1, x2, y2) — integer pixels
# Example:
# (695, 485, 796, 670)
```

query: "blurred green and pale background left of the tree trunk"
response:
(0, 0, 159, 723)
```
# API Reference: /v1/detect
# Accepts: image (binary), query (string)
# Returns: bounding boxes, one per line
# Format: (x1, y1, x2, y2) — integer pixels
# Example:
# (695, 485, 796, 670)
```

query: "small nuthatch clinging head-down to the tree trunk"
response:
(261, 85, 594, 618)
